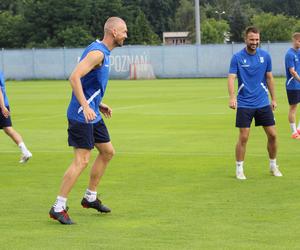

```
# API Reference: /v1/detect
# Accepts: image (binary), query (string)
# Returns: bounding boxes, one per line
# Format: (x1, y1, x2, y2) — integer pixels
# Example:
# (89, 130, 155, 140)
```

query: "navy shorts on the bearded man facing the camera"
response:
(235, 105, 275, 128)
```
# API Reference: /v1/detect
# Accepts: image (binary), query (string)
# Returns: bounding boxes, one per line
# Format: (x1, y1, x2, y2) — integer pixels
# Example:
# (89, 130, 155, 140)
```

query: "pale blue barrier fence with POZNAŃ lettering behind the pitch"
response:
(0, 43, 291, 79)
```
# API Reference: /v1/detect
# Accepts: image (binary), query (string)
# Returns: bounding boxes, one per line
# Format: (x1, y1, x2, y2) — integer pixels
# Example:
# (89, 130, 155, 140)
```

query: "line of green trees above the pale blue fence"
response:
(0, 0, 300, 48)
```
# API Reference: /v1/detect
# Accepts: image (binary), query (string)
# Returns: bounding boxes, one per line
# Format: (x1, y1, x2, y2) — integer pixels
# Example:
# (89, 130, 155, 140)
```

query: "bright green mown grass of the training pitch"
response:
(0, 78, 300, 250)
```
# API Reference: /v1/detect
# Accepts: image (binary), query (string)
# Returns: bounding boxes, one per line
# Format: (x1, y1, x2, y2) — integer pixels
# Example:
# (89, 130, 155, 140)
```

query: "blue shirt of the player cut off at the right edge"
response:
(285, 48, 300, 90)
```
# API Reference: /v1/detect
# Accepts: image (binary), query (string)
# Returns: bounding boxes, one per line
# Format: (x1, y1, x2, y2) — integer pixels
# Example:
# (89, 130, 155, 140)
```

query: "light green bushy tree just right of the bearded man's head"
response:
(251, 13, 299, 41)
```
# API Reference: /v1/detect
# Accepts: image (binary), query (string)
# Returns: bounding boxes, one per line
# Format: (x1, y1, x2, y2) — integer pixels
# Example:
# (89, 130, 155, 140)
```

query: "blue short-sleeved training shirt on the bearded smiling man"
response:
(229, 48, 272, 108)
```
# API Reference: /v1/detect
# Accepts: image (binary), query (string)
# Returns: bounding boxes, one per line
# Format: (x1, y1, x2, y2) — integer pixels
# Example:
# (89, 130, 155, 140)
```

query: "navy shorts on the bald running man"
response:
(68, 120, 110, 149)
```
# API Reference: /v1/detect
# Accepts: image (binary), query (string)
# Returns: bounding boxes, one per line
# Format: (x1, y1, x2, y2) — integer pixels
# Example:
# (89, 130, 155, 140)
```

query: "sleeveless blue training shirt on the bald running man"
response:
(67, 40, 110, 123)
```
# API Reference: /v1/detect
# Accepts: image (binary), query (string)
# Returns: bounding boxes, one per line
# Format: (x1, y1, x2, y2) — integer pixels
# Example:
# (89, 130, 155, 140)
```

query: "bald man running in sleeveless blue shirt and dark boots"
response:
(49, 17, 127, 224)
